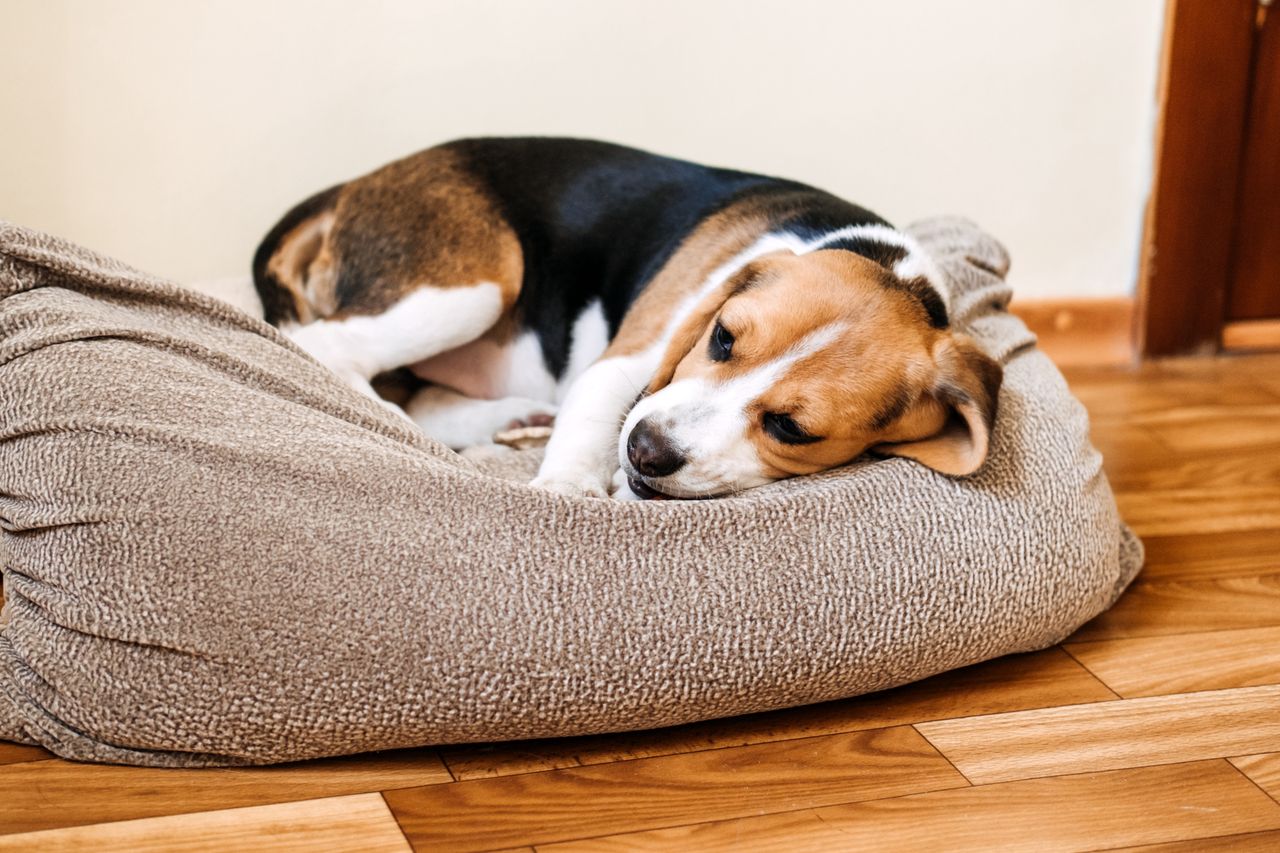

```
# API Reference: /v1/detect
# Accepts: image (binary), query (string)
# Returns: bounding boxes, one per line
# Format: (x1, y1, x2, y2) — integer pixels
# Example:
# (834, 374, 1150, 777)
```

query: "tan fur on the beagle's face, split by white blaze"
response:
(672, 251, 941, 478)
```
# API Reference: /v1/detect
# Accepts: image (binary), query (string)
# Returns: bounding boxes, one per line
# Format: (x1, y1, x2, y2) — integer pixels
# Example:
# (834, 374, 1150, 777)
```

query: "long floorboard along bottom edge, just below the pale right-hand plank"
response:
(538, 761, 1280, 853)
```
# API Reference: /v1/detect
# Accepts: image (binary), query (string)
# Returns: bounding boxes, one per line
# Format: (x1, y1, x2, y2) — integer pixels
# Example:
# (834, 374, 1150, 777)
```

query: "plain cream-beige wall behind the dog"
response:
(0, 0, 1162, 297)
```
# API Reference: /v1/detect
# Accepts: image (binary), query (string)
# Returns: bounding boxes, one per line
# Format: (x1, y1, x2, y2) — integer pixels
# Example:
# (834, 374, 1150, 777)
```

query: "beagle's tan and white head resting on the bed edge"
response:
(618, 250, 1002, 497)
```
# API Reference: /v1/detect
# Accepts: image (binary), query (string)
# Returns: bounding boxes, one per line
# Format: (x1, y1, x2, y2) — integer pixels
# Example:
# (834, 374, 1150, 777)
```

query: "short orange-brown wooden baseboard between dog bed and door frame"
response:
(1010, 297, 1137, 368)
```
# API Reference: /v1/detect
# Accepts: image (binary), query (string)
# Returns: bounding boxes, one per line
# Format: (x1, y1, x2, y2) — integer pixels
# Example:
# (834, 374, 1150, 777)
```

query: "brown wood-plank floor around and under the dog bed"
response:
(0, 356, 1280, 850)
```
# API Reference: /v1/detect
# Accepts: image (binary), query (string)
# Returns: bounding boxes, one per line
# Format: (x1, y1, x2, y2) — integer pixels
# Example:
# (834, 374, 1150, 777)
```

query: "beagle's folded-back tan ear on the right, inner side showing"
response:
(874, 334, 1005, 476)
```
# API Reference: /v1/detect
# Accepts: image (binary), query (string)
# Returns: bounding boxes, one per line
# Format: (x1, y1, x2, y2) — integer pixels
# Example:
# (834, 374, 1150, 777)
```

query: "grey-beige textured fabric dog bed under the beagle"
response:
(0, 213, 1142, 766)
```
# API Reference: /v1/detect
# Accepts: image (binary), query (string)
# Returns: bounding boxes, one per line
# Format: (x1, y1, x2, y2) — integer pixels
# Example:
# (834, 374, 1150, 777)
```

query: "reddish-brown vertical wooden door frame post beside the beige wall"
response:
(1138, 0, 1257, 356)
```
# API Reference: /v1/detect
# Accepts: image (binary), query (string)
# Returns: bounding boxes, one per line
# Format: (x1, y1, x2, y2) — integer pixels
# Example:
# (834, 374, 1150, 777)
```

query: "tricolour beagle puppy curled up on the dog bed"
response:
(253, 138, 1002, 498)
